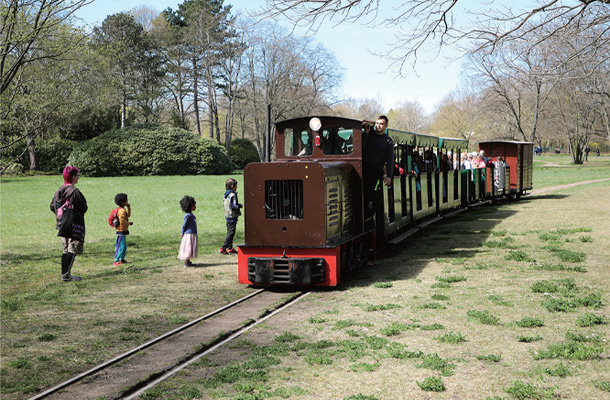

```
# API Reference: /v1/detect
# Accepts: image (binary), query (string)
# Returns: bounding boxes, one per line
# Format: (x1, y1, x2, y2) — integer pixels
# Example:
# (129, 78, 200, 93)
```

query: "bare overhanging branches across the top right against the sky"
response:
(260, 0, 610, 73)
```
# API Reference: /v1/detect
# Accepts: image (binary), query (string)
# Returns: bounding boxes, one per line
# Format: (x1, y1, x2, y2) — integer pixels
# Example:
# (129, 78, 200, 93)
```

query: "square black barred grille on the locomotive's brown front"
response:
(265, 180, 303, 219)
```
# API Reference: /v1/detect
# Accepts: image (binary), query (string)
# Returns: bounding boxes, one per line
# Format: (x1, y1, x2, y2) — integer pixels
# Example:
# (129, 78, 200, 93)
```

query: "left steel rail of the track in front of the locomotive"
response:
(29, 288, 267, 400)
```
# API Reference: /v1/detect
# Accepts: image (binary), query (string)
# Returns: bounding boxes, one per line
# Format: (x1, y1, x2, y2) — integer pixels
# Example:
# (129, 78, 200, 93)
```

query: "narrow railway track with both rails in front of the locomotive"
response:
(30, 288, 311, 400)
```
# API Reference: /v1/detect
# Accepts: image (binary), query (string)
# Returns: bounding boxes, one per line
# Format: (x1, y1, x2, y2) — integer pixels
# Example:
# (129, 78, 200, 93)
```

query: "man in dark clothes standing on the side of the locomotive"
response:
(362, 115, 394, 229)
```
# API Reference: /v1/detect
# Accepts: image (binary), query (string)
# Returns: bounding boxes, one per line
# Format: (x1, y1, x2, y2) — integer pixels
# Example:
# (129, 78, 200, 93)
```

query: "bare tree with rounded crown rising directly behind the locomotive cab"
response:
(239, 20, 341, 156)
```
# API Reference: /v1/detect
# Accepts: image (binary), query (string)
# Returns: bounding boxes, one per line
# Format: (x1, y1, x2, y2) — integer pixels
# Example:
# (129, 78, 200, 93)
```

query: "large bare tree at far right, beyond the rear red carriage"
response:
(460, 7, 610, 159)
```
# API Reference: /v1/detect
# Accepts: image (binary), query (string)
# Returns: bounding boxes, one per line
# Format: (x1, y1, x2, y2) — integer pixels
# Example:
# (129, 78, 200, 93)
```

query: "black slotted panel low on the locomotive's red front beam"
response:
(248, 257, 326, 285)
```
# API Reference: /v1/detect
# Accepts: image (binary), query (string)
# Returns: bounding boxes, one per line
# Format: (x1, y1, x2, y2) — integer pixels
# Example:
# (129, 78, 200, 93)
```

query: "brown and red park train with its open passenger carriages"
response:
(238, 116, 533, 286)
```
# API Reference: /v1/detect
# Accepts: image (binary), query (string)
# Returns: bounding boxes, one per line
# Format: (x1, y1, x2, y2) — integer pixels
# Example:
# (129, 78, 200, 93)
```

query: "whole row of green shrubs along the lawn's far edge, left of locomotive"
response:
(1, 125, 260, 176)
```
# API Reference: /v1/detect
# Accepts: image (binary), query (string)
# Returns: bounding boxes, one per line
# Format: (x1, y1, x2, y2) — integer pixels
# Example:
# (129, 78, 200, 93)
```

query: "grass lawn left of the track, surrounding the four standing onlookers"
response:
(0, 174, 250, 399)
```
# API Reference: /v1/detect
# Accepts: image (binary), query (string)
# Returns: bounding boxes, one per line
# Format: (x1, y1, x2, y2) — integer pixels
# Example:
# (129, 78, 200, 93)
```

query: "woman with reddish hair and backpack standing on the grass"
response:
(50, 166, 87, 282)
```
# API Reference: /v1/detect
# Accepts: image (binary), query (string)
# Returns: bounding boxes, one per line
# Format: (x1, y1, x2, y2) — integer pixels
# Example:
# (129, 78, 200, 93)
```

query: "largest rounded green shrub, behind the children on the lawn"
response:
(69, 125, 231, 176)
